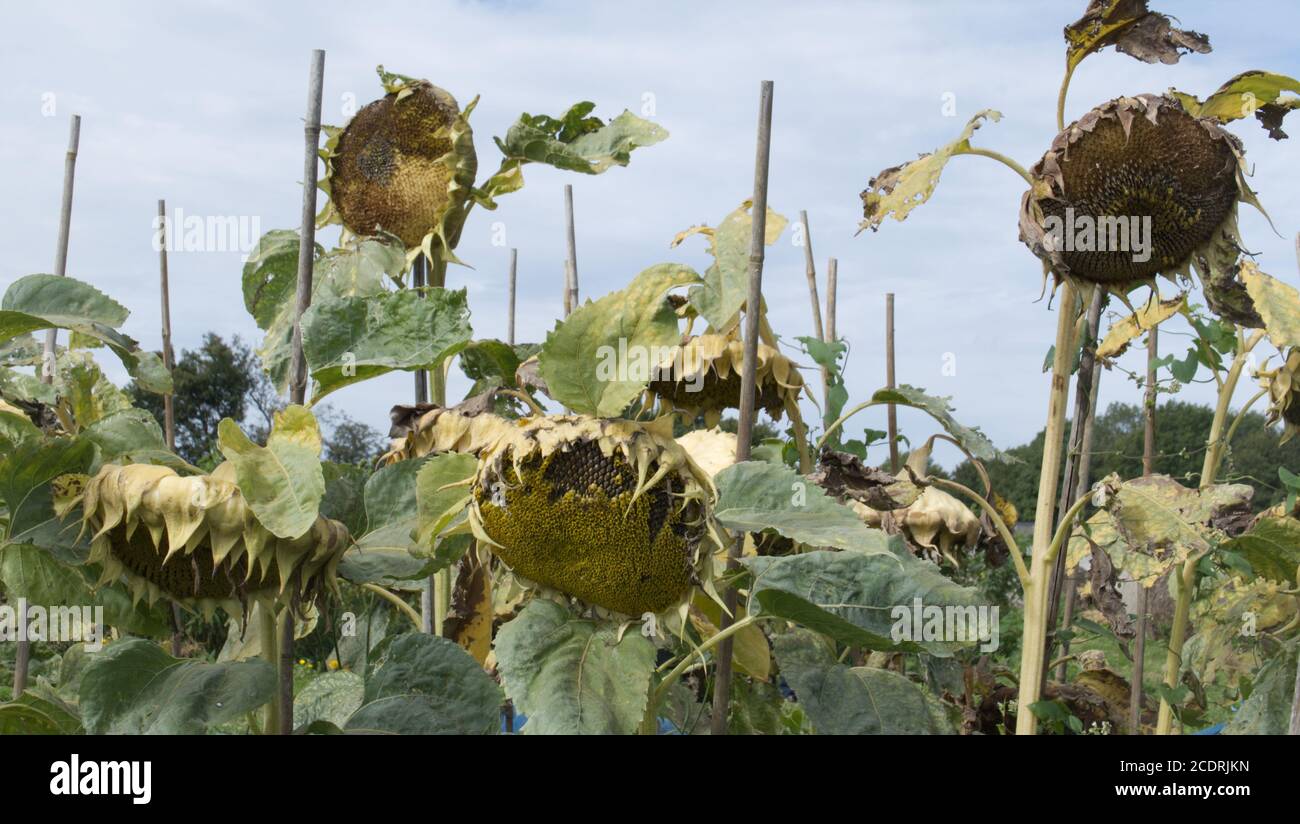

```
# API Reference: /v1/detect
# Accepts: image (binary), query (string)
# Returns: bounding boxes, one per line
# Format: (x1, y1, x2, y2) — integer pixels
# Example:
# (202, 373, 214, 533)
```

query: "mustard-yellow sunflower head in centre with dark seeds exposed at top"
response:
(471, 416, 720, 616)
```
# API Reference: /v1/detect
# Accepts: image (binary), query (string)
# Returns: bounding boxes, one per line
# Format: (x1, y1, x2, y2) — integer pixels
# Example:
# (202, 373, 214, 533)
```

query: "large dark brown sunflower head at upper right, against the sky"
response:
(1021, 95, 1249, 291)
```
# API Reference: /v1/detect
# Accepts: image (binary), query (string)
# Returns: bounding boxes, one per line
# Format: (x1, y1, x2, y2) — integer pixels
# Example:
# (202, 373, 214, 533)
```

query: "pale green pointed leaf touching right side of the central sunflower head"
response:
(714, 460, 889, 554)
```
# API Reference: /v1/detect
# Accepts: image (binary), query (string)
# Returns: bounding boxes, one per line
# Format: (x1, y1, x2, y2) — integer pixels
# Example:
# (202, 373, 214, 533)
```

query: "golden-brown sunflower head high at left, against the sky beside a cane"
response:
(324, 70, 477, 250)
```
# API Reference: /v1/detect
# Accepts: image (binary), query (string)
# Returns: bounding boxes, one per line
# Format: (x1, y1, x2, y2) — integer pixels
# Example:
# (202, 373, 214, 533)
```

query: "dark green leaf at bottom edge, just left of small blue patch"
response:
(345, 633, 502, 736)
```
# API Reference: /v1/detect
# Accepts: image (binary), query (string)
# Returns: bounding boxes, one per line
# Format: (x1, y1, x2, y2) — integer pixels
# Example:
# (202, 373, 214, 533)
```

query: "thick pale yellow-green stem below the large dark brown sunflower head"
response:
(1015, 281, 1079, 736)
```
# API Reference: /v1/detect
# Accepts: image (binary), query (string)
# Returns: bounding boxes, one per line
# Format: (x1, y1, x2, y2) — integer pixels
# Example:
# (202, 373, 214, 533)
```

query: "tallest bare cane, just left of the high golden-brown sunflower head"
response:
(278, 48, 325, 736)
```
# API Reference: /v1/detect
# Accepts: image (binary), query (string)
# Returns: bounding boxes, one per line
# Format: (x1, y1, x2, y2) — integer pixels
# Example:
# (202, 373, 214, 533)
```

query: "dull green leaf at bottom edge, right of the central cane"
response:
(774, 629, 956, 736)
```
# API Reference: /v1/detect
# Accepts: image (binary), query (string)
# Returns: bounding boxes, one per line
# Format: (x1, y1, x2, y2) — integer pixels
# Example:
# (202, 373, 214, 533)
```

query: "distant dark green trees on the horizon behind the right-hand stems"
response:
(954, 400, 1300, 520)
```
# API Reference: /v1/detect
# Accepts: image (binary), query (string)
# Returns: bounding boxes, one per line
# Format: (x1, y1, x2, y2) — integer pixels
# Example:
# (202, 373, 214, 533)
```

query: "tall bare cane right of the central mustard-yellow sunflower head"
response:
(710, 81, 774, 736)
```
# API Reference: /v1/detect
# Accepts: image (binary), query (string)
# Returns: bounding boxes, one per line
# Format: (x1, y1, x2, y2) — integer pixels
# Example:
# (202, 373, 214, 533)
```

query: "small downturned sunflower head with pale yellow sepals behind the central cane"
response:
(647, 333, 803, 426)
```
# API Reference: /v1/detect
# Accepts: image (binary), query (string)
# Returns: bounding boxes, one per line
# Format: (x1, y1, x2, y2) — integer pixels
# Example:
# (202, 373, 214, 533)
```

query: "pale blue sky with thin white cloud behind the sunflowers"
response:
(0, 0, 1300, 465)
